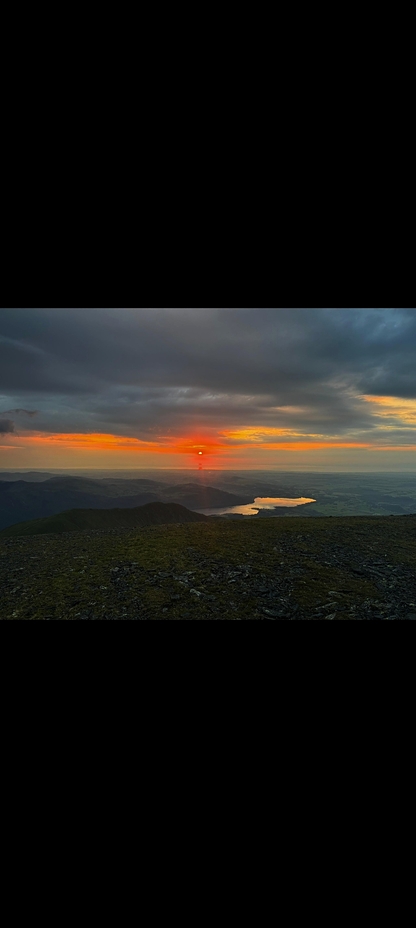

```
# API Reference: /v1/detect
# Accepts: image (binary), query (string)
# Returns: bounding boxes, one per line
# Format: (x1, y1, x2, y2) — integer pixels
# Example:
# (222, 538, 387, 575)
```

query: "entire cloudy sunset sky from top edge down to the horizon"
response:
(0, 308, 416, 472)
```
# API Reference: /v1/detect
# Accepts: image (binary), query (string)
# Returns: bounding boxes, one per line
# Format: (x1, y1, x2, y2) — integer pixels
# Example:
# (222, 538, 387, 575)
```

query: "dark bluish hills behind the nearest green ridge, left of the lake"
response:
(0, 476, 252, 530)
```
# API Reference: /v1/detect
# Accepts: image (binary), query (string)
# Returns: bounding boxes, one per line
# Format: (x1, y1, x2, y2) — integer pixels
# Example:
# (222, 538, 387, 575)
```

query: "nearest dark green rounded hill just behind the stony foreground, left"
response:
(0, 503, 209, 538)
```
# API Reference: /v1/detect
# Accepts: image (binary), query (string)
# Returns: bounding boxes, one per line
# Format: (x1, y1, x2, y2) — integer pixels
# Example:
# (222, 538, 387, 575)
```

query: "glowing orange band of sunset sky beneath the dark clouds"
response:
(0, 395, 416, 469)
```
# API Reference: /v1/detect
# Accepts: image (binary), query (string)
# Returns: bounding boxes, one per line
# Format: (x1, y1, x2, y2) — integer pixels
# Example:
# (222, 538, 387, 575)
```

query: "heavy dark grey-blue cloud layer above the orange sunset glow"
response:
(0, 309, 416, 438)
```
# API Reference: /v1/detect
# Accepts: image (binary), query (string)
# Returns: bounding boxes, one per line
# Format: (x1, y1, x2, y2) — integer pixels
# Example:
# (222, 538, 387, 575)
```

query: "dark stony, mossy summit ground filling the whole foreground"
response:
(0, 515, 416, 620)
